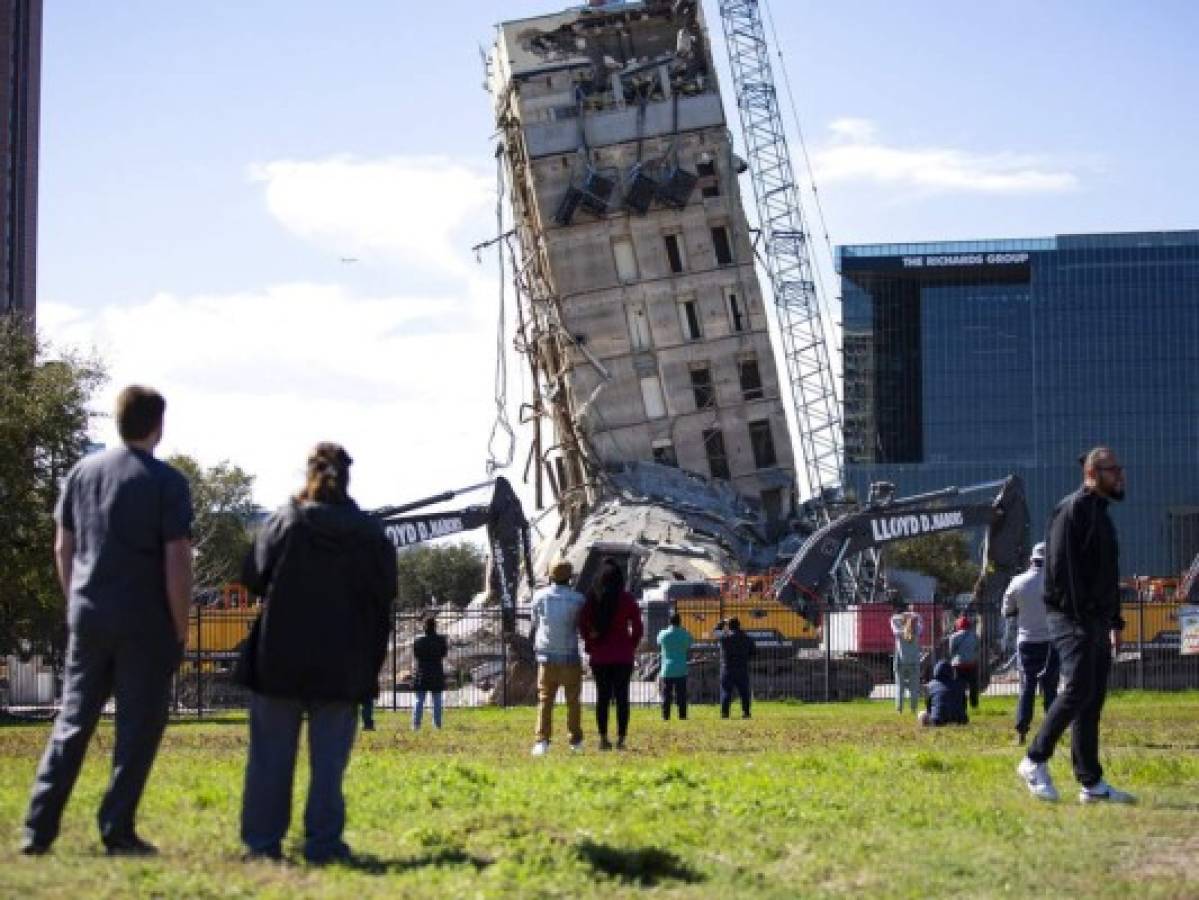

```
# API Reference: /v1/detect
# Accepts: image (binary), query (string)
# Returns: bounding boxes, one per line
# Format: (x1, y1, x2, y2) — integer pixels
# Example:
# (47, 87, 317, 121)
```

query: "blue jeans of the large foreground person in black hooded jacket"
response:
(241, 694, 359, 862)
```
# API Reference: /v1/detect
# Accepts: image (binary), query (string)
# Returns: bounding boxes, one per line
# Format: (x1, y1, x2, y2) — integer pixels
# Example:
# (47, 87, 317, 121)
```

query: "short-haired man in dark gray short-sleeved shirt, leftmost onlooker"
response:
(22, 386, 192, 856)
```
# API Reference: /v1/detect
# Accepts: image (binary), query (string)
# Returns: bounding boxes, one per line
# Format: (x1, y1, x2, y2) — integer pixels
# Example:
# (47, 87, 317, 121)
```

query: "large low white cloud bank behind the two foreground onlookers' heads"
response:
(38, 274, 517, 506)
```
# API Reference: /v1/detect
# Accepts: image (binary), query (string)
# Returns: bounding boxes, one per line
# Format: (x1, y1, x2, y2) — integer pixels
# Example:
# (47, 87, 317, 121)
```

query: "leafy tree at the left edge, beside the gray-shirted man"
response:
(0, 316, 104, 654)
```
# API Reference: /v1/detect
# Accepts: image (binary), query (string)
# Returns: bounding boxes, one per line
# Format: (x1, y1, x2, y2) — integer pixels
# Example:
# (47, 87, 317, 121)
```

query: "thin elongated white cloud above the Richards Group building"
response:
(813, 119, 1079, 194)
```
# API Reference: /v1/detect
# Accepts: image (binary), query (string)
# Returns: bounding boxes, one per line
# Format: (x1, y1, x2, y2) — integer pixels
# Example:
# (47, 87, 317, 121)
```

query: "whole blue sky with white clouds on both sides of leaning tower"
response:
(38, 0, 1199, 505)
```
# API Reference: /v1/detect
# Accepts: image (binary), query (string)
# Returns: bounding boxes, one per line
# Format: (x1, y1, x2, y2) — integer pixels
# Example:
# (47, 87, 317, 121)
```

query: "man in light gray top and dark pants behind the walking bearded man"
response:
(1004, 543, 1059, 745)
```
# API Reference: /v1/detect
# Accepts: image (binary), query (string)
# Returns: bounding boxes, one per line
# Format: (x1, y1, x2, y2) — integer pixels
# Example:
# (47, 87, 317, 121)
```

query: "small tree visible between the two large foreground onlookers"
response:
(167, 454, 258, 587)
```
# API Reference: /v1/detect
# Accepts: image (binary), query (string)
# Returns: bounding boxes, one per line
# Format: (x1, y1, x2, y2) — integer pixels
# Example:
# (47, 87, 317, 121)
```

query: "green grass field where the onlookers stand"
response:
(0, 693, 1199, 898)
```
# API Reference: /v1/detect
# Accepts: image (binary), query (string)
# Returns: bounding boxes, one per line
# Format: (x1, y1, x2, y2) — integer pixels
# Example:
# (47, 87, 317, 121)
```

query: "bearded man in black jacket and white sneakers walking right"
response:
(1017, 447, 1135, 803)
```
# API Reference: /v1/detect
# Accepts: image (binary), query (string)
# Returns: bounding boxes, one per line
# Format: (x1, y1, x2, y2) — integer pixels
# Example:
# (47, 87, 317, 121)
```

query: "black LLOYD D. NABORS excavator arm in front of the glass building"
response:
(773, 475, 1029, 618)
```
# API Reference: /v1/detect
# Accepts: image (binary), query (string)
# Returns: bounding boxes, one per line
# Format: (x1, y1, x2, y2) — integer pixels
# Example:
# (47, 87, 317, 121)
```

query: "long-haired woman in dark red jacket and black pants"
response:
(579, 557, 644, 750)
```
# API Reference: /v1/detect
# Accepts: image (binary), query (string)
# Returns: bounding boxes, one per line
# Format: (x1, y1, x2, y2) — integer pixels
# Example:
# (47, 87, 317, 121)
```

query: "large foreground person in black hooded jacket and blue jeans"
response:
(239, 443, 397, 863)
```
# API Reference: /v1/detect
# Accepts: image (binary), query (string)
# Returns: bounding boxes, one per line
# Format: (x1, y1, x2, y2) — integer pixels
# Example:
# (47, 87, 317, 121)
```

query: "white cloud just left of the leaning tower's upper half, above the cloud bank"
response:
(249, 156, 495, 274)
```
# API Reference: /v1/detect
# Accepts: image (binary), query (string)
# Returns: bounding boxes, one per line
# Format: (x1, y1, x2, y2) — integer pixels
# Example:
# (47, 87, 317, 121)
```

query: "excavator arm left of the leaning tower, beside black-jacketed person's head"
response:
(372, 477, 532, 633)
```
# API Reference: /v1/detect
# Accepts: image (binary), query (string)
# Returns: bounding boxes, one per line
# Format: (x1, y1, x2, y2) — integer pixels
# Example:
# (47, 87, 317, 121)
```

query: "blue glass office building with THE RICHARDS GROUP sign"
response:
(837, 231, 1199, 575)
